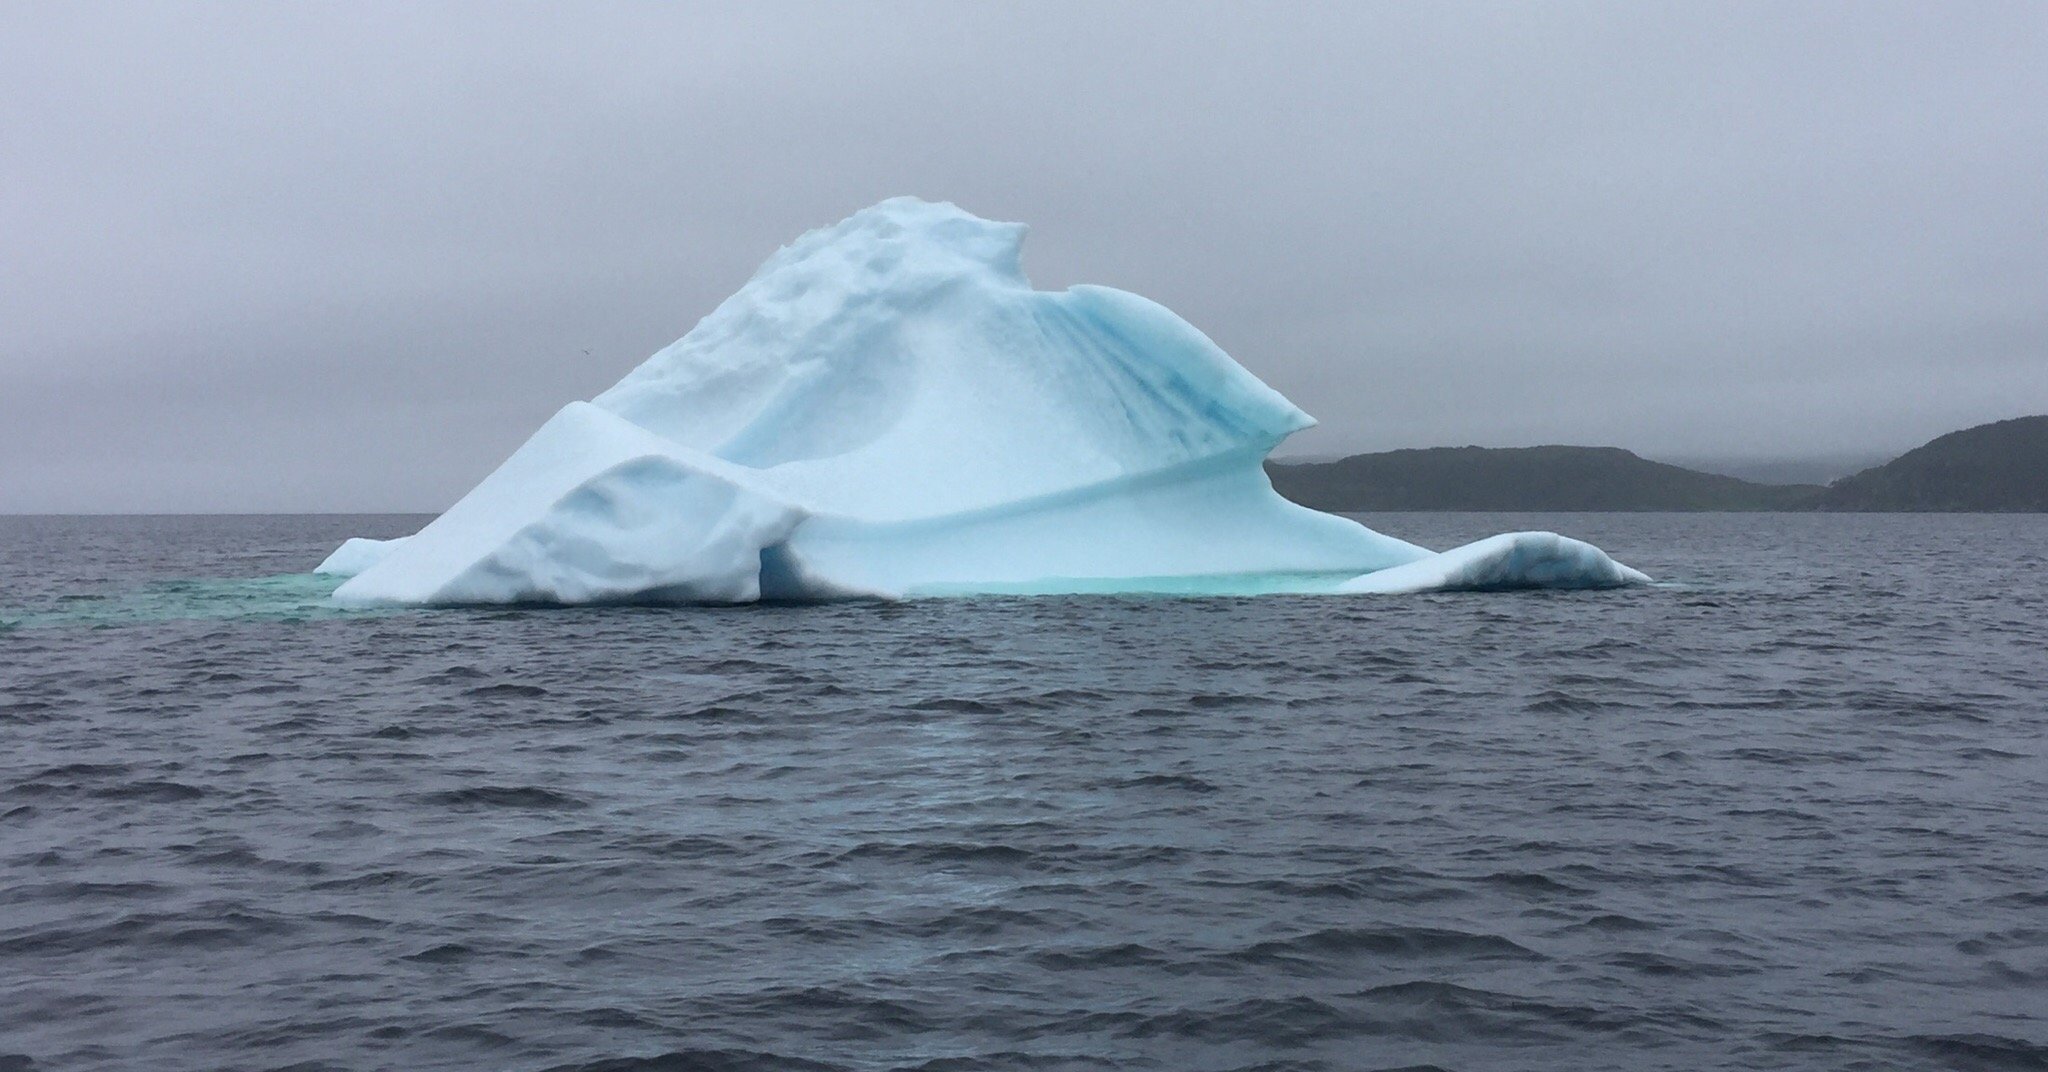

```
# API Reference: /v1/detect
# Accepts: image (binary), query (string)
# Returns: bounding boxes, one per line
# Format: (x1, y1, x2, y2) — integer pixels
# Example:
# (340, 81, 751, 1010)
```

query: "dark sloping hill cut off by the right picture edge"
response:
(1815, 416, 2048, 512)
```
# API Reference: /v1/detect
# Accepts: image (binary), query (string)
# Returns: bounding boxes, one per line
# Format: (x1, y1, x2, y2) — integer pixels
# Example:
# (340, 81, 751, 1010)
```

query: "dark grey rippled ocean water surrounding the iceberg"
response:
(0, 514, 2048, 1072)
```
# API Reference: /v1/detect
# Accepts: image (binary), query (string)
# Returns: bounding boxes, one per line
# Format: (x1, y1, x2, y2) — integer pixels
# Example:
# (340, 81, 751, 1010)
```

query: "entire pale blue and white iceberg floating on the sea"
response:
(335, 199, 1647, 605)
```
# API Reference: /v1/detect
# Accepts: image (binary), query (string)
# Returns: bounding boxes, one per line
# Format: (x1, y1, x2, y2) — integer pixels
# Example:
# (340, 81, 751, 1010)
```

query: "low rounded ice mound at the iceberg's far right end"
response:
(1337, 533, 1651, 594)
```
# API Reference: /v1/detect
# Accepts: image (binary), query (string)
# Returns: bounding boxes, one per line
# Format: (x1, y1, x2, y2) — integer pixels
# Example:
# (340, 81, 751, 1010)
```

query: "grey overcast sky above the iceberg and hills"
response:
(0, 0, 2048, 510)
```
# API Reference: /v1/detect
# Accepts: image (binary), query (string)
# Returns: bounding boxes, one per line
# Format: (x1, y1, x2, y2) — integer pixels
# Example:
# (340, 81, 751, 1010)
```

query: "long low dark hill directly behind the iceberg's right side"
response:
(1266, 447, 1823, 512)
